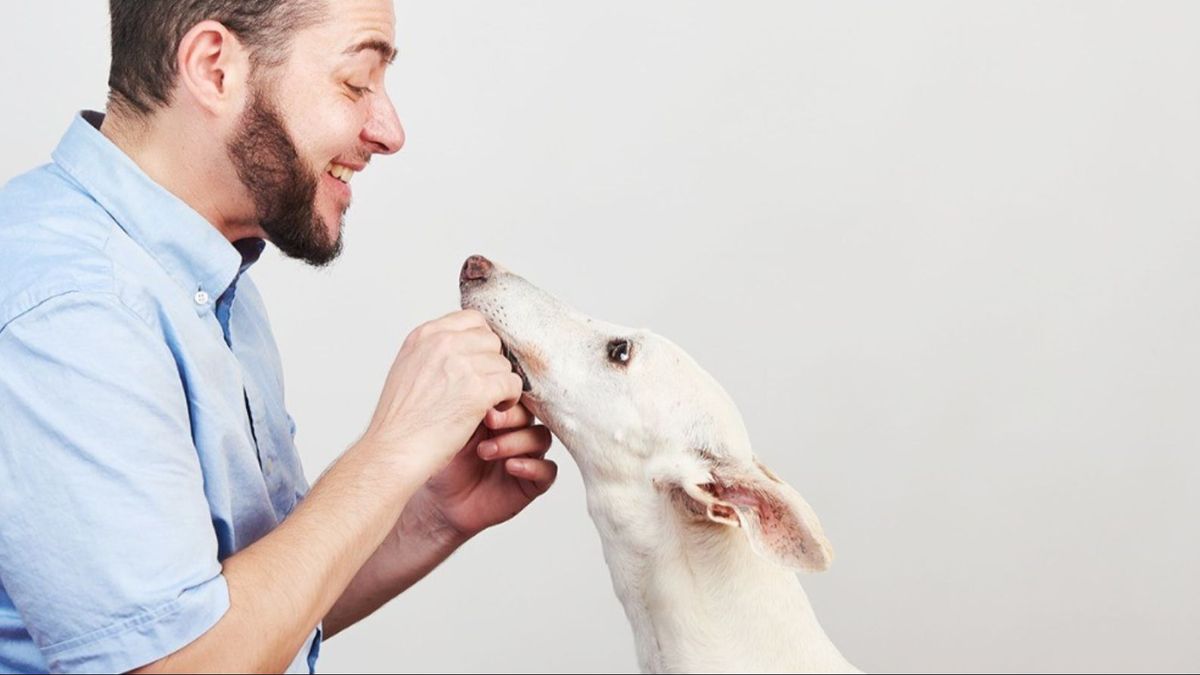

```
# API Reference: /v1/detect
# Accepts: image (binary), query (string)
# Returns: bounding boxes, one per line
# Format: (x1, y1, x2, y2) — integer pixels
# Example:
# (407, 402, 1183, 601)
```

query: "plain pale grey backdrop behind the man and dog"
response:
(0, 0, 1200, 673)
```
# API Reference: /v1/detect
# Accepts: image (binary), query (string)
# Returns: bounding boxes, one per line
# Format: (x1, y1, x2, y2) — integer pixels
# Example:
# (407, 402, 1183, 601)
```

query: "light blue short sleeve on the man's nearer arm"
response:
(0, 292, 229, 673)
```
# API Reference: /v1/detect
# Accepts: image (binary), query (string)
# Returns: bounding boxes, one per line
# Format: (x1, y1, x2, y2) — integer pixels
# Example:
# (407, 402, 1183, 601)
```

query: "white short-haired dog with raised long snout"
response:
(460, 256, 857, 673)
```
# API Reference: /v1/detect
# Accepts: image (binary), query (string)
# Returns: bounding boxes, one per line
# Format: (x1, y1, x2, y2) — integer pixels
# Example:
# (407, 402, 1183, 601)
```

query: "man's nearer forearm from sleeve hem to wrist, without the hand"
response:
(132, 443, 425, 673)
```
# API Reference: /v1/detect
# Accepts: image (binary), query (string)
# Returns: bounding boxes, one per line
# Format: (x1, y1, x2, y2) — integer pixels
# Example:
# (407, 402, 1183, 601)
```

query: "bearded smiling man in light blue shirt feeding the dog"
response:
(0, 0, 556, 673)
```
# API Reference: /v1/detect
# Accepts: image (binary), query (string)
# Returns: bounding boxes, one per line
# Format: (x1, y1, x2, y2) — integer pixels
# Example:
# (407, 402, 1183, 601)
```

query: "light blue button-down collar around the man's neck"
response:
(52, 110, 265, 305)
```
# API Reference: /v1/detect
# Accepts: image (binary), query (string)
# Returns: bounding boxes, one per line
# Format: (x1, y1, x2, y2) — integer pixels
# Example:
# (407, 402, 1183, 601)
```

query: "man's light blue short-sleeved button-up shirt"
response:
(0, 113, 320, 673)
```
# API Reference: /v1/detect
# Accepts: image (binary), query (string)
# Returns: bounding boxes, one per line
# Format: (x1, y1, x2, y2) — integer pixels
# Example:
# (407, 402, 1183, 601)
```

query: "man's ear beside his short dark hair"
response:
(175, 20, 251, 114)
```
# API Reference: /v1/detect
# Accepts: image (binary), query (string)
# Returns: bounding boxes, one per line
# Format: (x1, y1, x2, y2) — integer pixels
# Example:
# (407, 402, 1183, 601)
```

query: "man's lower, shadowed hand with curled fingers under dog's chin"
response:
(397, 404, 558, 542)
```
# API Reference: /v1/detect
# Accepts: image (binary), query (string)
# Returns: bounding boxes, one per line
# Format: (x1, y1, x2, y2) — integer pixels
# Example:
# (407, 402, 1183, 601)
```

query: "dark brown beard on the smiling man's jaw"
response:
(227, 86, 343, 267)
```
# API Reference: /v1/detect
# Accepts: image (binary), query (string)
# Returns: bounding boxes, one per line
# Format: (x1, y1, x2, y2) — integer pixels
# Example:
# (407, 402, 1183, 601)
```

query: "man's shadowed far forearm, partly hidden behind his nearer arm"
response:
(323, 480, 468, 639)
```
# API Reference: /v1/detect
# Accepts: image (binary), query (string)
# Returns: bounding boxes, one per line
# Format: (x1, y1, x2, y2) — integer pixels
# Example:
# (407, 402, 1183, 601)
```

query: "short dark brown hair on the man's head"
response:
(108, 0, 326, 117)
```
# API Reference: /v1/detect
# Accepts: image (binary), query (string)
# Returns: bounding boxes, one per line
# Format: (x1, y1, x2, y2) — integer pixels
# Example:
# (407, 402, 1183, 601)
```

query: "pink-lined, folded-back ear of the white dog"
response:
(660, 454, 833, 572)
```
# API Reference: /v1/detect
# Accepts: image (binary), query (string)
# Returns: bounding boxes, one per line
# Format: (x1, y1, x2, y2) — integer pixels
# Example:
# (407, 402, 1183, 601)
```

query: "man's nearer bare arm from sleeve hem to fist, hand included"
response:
(130, 311, 521, 673)
